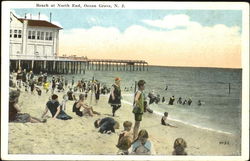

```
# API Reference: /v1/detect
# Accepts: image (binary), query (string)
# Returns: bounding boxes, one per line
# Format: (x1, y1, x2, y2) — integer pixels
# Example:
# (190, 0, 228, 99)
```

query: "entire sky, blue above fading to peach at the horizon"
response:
(12, 8, 242, 68)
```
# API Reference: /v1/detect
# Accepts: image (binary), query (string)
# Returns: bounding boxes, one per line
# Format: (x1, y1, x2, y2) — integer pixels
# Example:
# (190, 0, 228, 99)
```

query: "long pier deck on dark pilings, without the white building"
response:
(10, 56, 148, 74)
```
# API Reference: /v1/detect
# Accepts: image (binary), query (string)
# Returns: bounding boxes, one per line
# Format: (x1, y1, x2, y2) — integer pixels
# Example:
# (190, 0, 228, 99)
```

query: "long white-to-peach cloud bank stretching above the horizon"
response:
(59, 14, 241, 68)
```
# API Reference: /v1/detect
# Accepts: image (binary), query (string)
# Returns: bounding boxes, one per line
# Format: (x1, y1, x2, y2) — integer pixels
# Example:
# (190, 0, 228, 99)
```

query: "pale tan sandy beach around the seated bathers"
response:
(8, 85, 241, 156)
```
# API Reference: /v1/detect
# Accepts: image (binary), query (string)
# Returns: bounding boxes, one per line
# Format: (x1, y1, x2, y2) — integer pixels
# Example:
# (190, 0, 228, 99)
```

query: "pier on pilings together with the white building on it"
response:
(9, 12, 148, 74)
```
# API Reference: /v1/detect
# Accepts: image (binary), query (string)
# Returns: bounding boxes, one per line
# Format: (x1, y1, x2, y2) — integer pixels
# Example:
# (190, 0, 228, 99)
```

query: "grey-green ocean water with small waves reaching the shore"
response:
(51, 67, 242, 135)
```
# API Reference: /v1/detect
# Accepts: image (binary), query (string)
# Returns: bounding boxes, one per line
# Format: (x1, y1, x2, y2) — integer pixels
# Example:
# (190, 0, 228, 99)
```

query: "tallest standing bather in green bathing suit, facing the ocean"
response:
(133, 80, 146, 139)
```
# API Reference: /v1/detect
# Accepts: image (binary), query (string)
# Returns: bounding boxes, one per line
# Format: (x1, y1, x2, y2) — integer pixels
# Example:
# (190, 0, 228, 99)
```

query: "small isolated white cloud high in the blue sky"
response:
(142, 14, 200, 29)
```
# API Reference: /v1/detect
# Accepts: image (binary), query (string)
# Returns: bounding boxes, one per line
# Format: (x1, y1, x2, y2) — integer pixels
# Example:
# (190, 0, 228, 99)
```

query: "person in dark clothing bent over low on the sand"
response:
(94, 117, 119, 134)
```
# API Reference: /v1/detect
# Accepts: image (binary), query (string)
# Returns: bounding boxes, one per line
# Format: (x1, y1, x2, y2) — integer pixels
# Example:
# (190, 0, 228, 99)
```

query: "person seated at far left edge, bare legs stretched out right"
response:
(9, 90, 46, 123)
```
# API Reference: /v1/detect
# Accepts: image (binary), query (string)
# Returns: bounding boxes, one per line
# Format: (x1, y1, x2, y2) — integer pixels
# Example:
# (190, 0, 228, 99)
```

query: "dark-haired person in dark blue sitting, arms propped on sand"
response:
(42, 94, 72, 120)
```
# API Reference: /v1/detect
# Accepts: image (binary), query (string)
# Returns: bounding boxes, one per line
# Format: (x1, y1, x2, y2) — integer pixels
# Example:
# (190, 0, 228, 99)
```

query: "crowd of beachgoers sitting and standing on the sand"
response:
(9, 68, 187, 155)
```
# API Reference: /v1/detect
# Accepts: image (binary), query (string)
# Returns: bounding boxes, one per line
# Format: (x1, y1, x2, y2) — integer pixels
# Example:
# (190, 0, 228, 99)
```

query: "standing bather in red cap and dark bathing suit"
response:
(108, 77, 121, 116)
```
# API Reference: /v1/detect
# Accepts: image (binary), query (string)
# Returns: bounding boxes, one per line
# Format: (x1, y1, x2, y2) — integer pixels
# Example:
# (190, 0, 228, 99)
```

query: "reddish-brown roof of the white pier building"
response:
(17, 18, 62, 30)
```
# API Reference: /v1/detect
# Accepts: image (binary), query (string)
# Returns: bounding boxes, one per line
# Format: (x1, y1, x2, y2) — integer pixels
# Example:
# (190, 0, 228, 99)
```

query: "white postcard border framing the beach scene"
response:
(1, 1, 249, 160)
